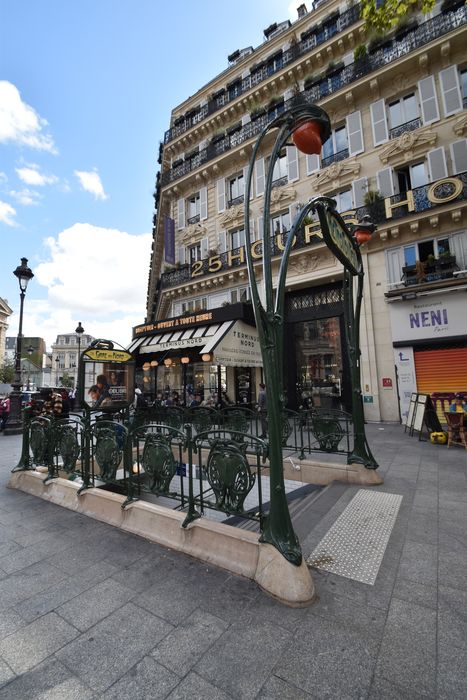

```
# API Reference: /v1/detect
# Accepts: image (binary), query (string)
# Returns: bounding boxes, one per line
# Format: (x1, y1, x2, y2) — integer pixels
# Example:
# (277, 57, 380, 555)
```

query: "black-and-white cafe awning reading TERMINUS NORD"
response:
(129, 320, 262, 367)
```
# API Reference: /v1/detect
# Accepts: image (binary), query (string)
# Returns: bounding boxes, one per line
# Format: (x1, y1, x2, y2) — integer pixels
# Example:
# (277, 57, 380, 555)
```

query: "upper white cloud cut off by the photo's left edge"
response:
(0, 80, 57, 153)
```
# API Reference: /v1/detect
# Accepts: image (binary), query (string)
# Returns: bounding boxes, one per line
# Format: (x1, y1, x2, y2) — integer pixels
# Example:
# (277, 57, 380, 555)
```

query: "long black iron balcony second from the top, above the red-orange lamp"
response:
(161, 5, 467, 186)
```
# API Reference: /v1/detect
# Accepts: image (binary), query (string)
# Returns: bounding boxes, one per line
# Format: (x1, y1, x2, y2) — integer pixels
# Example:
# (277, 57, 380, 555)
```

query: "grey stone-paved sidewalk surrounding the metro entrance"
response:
(0, 425, 467, 700)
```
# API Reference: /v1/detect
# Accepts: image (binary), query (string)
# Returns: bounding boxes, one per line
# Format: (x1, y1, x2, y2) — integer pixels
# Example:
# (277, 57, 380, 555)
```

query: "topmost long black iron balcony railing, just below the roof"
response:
(164, 4, 360, 143)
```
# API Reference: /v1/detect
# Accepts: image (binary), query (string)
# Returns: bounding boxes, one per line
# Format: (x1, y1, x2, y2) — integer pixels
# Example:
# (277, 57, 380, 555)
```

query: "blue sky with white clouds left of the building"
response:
(0, 0, 298, 349)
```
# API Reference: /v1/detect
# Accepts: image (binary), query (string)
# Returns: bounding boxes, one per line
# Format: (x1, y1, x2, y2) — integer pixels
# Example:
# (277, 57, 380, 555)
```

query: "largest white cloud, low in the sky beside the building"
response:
(8, 223, 152, 347)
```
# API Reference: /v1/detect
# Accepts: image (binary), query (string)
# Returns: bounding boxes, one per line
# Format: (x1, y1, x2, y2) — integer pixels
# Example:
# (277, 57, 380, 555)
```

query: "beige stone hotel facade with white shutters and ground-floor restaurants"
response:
(131, 0, 467, 421)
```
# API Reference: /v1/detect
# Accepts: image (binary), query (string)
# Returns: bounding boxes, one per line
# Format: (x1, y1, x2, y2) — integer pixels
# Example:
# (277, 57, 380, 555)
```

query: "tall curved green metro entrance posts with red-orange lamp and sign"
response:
(245, 102, 378, 566)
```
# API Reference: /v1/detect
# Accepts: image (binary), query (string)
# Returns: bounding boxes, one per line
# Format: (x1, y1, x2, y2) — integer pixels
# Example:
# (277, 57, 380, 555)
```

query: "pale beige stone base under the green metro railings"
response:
(8, 470, 314, 607)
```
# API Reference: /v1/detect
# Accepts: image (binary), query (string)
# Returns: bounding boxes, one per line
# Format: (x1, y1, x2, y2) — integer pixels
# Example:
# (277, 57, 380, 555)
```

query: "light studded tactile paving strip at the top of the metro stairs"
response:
(307, 489, 402, 585)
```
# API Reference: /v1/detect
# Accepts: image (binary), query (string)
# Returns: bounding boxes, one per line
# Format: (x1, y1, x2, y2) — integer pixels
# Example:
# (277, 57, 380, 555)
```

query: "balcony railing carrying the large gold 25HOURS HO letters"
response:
(160, 172, 467, 289)
